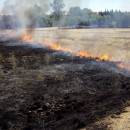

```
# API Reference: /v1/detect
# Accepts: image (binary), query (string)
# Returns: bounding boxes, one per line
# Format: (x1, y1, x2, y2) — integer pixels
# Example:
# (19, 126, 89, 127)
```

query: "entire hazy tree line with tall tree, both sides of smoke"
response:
(0, 0, 130, 28)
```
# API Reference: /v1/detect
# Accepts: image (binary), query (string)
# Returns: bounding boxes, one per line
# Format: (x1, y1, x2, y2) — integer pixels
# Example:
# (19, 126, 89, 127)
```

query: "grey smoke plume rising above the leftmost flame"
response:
(1, 0, 51, 29)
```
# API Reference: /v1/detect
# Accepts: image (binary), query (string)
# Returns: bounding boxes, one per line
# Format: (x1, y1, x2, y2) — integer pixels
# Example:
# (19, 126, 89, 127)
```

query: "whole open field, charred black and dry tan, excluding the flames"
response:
(0, 28, 130, 130)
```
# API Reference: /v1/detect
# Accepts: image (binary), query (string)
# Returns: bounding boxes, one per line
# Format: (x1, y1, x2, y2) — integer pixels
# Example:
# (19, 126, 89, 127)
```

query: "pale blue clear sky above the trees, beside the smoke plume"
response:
(0, 0, 130, 12)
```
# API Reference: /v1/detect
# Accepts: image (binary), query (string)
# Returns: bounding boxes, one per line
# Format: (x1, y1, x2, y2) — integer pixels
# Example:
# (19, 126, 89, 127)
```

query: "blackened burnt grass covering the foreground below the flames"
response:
(0, 43, 130, 130)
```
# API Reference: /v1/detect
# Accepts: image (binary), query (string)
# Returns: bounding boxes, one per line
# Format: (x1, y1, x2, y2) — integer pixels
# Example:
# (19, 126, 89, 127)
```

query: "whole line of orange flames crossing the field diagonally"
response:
(21, 31, 130, 70)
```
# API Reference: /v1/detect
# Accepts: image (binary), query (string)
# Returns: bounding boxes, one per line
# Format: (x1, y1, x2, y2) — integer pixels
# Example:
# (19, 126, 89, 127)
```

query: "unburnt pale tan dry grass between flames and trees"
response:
(33, 28, 130, 62)
